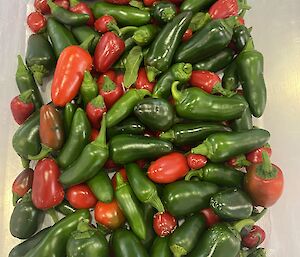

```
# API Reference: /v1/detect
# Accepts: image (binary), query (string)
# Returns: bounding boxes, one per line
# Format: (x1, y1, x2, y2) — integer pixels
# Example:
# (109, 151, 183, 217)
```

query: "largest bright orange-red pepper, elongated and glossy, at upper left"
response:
(51, 46, 93, 107)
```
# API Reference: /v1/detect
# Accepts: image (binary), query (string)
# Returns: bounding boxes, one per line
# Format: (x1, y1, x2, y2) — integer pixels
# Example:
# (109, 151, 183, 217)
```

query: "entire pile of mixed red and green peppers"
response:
(9, 0, 284, 257)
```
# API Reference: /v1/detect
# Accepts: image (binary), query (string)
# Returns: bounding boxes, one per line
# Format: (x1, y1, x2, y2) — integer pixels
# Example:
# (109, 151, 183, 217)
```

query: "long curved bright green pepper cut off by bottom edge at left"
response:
(24, 210, 90, 257)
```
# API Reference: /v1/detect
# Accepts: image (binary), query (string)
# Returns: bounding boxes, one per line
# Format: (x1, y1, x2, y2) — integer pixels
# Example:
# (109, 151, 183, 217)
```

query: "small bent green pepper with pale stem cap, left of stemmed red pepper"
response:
(153, 63, 193, 99)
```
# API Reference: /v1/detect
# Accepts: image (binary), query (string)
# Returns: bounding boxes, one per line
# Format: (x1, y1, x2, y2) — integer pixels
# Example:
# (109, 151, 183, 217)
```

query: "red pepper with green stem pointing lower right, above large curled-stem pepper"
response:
(190, 70, 235, 97)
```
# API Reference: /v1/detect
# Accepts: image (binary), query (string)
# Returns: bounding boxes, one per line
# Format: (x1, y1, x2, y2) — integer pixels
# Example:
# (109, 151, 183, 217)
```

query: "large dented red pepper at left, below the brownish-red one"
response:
(32, 158, 65, 210)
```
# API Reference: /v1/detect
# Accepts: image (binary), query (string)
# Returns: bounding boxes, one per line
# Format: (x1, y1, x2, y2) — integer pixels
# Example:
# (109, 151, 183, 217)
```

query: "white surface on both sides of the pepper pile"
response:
(0, 0, 300, 257)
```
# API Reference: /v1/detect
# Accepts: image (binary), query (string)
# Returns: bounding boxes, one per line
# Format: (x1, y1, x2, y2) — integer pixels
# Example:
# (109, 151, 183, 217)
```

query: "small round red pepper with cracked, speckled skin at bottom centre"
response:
(153, 212, 177, 237)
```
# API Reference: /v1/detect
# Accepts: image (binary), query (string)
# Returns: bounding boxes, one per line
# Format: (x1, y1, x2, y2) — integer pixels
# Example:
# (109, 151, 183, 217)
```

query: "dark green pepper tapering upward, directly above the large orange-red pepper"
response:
(47, 17, 77, 58)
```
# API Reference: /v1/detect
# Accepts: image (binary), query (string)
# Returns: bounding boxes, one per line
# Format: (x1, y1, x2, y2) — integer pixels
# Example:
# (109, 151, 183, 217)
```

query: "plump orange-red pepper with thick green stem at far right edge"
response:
(244, 152, 284, 207)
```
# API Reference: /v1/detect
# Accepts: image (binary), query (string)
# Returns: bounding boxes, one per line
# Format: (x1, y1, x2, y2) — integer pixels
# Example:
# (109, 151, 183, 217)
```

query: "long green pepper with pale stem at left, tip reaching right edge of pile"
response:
(191, 129, 270, 162)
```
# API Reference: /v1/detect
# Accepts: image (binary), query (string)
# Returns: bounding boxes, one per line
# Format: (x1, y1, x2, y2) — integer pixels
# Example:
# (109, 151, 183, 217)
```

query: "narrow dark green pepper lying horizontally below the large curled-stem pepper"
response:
(159, 123, 230, 146)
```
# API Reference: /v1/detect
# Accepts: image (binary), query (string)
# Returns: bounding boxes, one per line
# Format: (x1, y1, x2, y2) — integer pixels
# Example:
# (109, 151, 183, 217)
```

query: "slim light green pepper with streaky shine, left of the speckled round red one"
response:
(115, 173, 146, 240)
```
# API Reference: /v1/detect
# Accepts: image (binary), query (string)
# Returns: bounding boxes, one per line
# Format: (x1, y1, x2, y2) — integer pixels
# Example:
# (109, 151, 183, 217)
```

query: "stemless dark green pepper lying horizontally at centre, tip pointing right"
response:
(109, 134, 173, 164)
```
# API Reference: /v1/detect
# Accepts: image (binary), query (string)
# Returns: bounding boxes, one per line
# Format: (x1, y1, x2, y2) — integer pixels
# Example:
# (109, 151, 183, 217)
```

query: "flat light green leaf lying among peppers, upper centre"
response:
(124, 46, 143, 88)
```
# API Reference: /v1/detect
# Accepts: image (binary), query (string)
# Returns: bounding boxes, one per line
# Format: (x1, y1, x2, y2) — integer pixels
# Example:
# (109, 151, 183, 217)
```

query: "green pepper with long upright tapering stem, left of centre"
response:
(59, 115, 109, 186)
